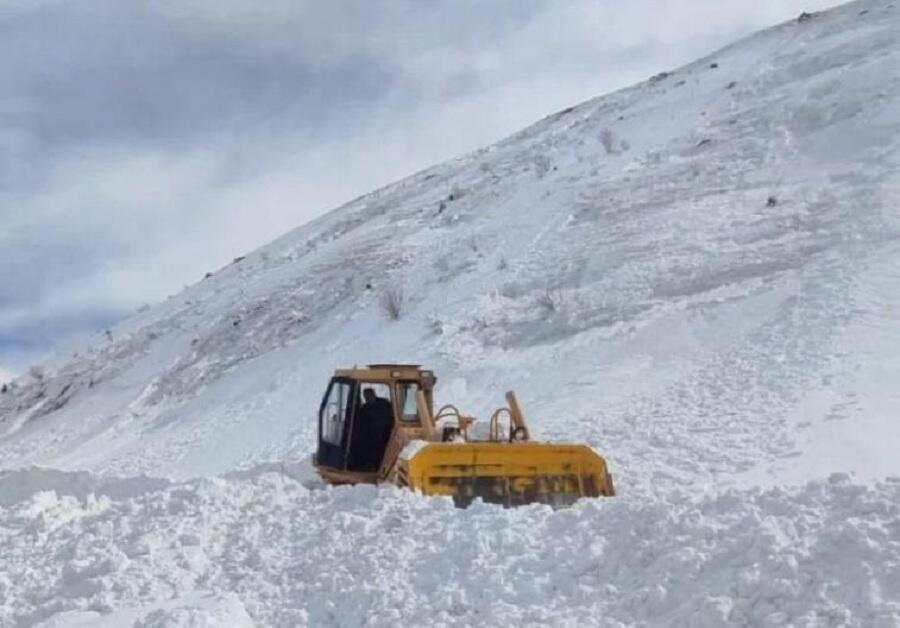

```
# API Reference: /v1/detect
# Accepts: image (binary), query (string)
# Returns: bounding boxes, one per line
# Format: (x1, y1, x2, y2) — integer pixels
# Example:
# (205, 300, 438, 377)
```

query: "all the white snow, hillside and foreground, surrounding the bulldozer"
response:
(0, 0, 900, 626)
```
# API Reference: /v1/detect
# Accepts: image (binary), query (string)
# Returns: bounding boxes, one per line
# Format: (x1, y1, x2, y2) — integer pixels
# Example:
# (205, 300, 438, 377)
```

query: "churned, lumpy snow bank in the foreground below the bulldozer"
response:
(0, 473, 900, 627)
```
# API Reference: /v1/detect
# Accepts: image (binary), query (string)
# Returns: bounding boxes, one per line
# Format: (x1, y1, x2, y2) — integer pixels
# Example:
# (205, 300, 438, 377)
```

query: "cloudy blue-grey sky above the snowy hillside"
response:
(0, 0, 833, 381)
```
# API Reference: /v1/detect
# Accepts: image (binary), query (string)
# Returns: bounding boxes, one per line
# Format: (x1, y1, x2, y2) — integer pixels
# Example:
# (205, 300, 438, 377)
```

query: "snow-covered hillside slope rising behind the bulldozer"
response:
(0, 2, 900, 488)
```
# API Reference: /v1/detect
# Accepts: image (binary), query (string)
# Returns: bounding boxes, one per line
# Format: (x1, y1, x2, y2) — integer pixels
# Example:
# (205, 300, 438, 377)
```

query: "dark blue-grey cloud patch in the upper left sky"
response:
(0, 2, 391, 152)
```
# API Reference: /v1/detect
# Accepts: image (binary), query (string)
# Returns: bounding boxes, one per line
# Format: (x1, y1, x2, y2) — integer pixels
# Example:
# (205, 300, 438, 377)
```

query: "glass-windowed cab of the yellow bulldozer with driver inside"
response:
(316, 365, 434, 481)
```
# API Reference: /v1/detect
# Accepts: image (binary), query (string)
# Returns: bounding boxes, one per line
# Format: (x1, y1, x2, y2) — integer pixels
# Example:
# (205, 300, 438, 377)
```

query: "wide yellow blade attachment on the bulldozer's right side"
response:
(396, 442, 615, 507)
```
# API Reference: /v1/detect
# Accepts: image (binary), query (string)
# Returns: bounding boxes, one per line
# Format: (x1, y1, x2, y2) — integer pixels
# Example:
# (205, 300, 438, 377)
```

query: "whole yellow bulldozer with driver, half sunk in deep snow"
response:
(313, 364, 615, 507)
